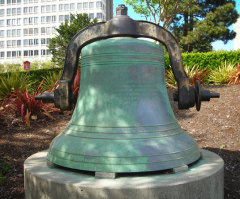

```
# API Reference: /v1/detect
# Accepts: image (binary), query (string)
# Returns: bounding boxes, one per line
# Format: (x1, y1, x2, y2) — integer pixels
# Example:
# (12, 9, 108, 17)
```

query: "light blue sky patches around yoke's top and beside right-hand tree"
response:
(113, 0, 240, 51)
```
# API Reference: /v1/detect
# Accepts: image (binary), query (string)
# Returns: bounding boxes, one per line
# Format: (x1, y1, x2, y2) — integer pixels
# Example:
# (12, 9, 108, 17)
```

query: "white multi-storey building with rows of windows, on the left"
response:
(0, 0, 113, 63)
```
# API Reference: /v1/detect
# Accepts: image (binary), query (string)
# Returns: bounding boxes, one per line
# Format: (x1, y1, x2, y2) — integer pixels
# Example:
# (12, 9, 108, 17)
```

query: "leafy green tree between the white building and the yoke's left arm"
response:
(48, 13, 97, 66)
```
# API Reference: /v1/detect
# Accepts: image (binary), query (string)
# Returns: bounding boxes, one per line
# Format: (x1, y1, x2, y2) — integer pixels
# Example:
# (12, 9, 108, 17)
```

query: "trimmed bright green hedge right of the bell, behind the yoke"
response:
(165, 50, 240, 70)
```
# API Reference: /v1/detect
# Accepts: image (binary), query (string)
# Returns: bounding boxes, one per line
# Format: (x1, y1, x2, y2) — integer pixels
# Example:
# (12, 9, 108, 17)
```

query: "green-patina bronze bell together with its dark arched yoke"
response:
(37, 5, 219, 173)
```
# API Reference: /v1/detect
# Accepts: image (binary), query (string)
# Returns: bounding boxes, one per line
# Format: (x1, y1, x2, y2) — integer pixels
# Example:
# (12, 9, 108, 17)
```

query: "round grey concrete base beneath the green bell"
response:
(24, 150, 224, 199)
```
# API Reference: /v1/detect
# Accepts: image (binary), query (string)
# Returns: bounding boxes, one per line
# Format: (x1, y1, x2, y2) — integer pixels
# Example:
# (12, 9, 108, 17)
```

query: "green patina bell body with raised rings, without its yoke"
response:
(48, 38, 200, 173)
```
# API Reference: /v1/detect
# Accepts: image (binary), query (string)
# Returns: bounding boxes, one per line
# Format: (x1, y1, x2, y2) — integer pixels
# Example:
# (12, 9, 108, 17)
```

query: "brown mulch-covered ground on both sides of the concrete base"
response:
(0, 85, 240, 199)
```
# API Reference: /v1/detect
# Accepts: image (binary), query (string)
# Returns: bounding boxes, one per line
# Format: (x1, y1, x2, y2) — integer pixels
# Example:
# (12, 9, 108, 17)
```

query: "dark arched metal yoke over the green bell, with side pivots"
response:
(36, 5, 219, 110)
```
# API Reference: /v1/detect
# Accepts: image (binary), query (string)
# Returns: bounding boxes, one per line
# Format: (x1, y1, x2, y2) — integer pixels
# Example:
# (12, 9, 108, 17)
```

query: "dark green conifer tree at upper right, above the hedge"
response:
(171, 0, 238, 52)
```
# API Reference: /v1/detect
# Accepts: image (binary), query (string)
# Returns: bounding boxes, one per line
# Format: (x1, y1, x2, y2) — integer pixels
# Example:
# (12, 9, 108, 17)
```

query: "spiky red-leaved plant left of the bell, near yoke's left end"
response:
(10, 81, 55, 126)
